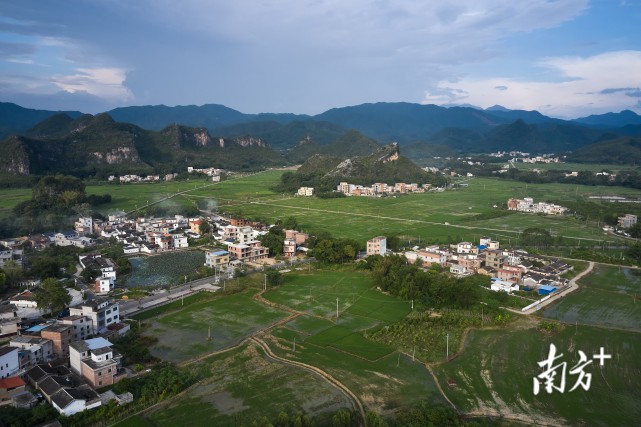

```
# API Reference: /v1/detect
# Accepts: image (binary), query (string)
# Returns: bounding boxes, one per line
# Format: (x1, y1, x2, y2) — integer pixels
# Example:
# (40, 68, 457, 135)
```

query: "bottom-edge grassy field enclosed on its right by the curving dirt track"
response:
(123, 345, 351, 426)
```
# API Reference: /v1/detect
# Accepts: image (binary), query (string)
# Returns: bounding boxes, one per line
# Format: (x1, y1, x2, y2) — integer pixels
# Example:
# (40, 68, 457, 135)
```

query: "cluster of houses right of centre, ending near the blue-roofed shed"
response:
(367, 236, 572, 295)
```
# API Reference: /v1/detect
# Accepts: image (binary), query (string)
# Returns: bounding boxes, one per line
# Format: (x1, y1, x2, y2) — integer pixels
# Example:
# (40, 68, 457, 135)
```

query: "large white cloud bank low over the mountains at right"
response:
(423, 51, 641, 117)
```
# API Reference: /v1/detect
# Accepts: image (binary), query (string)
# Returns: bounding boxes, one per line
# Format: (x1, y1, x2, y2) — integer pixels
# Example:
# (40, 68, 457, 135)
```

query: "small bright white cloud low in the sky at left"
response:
(51, 68, 132, 101)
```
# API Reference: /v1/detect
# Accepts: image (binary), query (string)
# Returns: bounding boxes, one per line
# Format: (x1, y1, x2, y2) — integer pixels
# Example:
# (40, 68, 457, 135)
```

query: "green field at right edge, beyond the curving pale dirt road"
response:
(543, 265, 641, 332)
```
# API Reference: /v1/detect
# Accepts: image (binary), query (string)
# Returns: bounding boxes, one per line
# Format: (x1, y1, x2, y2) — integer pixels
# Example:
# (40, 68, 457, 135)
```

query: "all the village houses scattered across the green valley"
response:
(0, 196, 636, 415)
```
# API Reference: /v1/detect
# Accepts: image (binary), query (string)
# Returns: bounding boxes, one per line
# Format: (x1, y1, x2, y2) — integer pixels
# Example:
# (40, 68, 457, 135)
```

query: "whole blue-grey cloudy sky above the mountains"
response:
(0, 0, 641, 118)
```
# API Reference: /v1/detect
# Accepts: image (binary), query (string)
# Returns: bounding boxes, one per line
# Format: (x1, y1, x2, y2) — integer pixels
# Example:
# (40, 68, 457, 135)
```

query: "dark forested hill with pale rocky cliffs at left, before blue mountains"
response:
(0, 114, 285, 178)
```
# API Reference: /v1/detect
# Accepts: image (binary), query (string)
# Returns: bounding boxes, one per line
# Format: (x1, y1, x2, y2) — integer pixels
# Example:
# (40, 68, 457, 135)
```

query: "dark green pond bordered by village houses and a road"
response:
(126, 251, 205, 286)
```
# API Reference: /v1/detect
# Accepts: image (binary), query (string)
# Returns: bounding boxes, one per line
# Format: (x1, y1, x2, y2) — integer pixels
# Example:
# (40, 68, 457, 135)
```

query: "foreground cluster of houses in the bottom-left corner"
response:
(0, 299, 133, 415)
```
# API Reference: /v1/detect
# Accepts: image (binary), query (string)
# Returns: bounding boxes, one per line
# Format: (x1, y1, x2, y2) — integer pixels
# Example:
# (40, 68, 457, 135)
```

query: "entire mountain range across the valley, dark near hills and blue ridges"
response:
(0, 103, 641, 175)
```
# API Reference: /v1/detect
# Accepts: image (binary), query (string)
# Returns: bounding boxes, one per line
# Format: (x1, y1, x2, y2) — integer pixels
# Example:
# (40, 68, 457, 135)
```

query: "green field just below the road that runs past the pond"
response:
(143, 290, 285, 362)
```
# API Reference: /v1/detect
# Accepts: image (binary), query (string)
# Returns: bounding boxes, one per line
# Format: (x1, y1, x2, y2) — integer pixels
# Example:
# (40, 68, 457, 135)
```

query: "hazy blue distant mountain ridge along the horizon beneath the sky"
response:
(0, 102, 641, 167)
